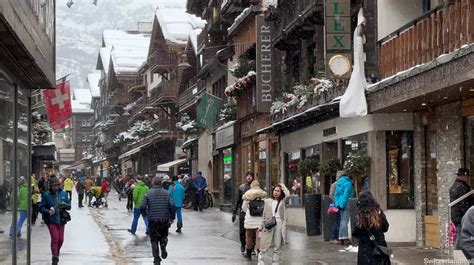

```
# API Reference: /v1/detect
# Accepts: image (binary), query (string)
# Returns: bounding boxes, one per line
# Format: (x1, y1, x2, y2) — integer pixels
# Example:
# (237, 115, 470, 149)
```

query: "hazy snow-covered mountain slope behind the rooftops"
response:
(56, 0, 160, 89)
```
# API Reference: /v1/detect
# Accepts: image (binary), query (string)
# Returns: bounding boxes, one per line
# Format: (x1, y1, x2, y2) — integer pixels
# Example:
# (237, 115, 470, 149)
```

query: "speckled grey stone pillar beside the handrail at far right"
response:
(436, 102, 463, 250)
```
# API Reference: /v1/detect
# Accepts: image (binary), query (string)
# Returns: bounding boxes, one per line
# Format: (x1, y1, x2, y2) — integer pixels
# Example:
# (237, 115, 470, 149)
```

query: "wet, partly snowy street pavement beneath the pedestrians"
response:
(0, 190, 456, 265)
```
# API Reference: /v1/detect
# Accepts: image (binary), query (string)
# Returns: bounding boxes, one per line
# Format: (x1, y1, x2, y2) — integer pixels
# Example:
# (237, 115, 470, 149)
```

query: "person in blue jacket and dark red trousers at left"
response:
(40, 175, 71, 265)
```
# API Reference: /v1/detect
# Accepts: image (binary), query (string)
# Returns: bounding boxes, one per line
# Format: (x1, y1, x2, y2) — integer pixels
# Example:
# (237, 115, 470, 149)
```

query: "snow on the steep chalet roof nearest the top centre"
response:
(156, 5, 206, 44)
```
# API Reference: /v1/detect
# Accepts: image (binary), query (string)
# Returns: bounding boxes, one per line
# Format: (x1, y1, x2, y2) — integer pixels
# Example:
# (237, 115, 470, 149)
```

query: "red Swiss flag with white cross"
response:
(43, 76, 72, 131)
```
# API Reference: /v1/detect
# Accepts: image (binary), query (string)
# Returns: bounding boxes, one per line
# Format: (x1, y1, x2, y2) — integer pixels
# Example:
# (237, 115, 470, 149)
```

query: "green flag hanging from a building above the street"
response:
(197, 92, 222, 129)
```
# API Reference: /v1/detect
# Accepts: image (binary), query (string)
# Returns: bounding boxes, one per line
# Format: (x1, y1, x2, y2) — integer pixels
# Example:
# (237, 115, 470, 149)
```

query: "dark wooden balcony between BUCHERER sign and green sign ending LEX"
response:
(268, 0, 324, 47)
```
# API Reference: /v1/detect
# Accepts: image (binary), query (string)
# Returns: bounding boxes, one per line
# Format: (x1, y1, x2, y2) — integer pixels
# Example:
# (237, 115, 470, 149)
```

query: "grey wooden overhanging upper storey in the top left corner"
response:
(0, 0, 56, 85)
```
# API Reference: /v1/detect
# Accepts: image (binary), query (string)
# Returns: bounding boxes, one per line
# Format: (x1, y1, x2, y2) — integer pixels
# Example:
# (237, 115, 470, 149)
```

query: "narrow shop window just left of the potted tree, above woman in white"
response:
(285, 150, 302, 206)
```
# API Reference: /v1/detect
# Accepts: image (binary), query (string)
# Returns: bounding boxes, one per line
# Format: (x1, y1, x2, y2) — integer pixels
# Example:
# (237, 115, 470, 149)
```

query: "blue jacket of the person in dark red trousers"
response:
(39, 189, 71, 224)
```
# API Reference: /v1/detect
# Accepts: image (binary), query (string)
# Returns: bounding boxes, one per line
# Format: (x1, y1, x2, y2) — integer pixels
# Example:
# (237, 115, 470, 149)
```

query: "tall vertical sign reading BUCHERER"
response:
(255, 15, 275, 113)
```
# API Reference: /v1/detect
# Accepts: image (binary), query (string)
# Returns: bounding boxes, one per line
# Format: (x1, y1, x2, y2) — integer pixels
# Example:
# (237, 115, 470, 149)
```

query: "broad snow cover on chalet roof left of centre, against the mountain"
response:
(101, 30, 150, 73)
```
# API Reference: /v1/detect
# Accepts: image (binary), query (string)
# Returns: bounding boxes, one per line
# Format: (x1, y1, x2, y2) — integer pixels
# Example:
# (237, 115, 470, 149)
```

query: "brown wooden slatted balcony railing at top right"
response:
(378, 0, 474, 78)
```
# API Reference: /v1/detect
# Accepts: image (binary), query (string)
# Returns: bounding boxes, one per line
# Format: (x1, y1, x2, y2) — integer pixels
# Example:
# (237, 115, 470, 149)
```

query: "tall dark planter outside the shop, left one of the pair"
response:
(304, 194, 321, 236)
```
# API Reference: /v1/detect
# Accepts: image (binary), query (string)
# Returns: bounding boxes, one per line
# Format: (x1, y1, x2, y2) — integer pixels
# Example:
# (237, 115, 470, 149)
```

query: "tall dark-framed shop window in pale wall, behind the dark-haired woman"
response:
(386, 131, 415, 209)
